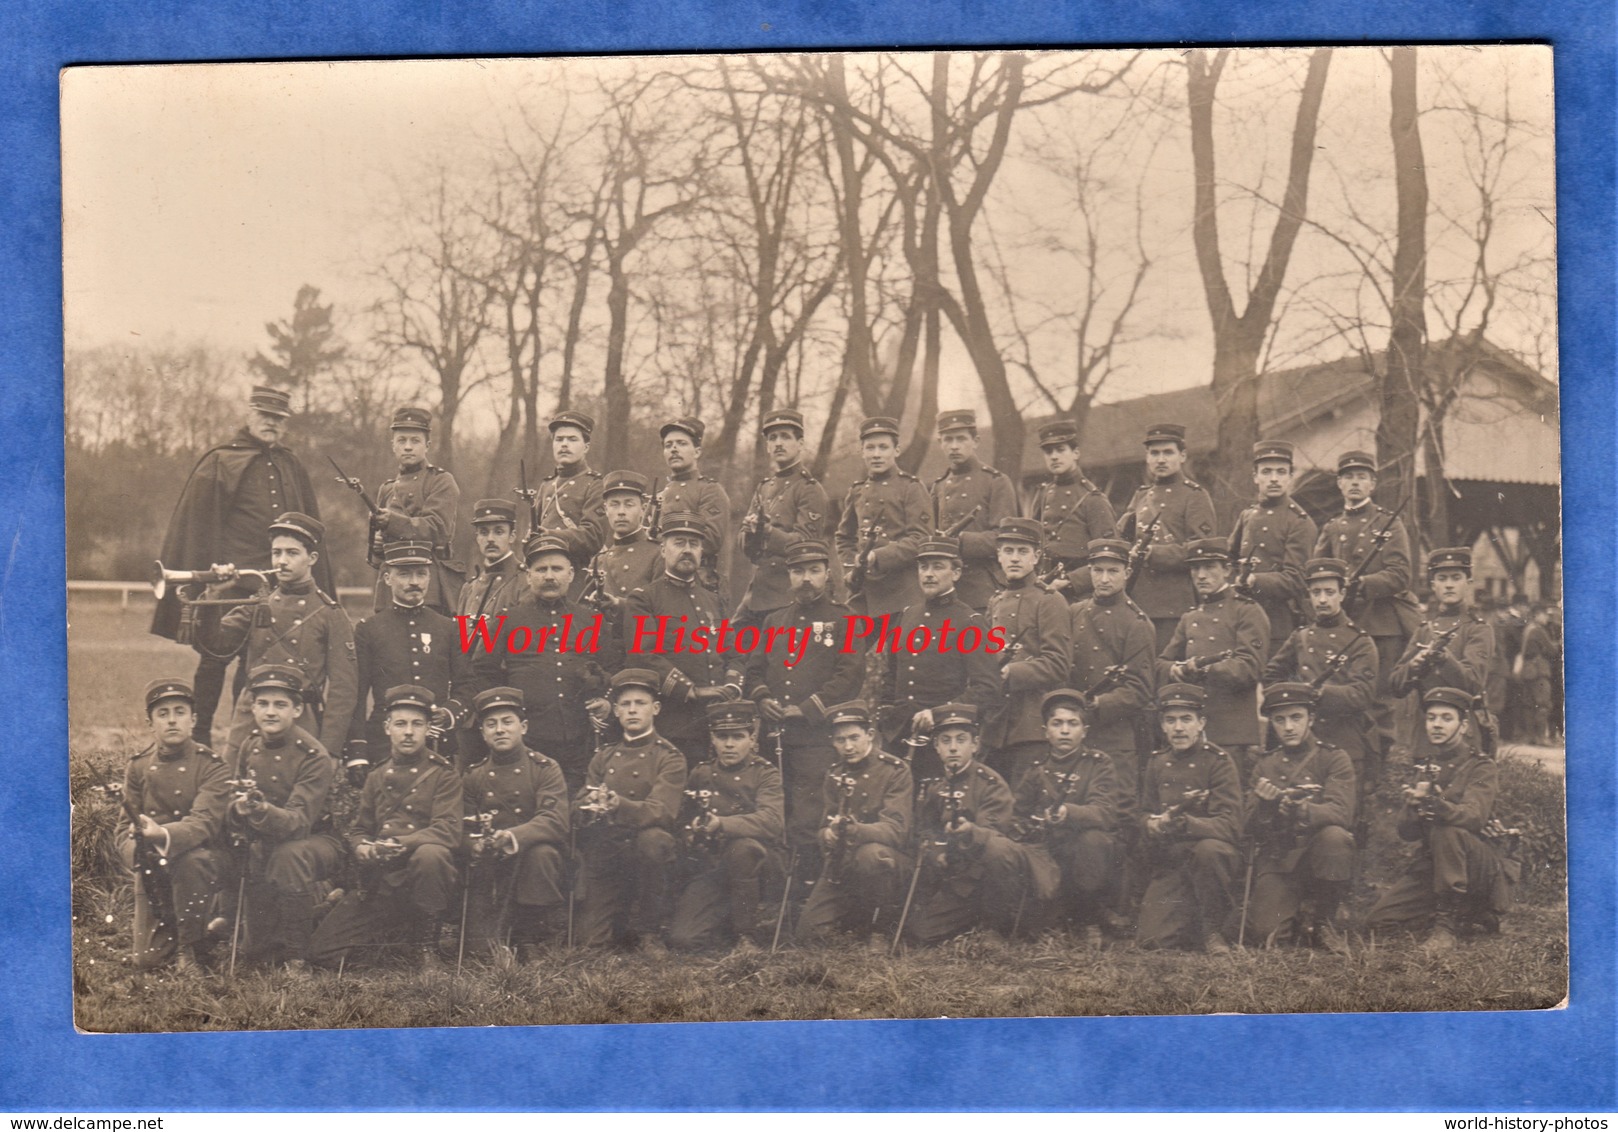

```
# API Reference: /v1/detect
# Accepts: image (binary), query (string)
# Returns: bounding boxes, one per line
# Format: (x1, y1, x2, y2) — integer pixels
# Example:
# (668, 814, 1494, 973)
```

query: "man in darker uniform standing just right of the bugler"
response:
(343, 542, 472, 767)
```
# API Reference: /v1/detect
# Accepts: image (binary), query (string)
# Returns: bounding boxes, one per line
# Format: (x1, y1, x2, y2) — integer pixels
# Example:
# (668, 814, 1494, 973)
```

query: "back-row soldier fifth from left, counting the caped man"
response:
(733, 409, 832, 624)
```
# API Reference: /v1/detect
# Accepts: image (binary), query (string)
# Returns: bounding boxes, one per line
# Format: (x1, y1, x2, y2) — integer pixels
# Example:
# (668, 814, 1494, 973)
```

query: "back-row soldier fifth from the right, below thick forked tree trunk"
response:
(932, 409, 1019, 613)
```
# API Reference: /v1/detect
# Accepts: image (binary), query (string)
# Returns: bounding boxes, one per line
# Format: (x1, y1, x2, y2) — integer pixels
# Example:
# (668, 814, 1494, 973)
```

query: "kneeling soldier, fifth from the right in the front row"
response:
(909, 703, 1022, 943)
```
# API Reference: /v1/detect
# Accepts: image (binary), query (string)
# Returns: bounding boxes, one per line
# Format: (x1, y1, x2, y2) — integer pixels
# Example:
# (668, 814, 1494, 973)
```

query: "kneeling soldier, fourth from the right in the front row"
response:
(1013, 687, 1133, 948)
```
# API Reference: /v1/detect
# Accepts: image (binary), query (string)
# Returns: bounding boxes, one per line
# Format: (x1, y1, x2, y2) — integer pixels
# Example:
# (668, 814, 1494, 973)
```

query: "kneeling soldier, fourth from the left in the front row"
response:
(463, 687, 568, 961)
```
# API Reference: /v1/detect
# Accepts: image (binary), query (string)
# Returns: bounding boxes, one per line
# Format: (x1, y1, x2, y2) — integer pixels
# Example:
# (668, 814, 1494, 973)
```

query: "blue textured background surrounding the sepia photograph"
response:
(0, 0, 1618, 1111)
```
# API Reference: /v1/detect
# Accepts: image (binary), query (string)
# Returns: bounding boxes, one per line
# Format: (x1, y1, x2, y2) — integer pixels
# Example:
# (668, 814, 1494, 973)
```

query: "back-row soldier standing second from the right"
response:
(1230, 440, 1317, 660)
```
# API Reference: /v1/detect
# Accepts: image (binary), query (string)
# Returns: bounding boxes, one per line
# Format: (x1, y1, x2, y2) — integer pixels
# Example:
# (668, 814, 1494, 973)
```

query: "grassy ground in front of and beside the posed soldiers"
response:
(68, 598, 1568, 1032)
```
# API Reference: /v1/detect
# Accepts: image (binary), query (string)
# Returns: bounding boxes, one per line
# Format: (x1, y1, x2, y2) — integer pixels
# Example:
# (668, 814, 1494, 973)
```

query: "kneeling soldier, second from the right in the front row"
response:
(1243, 684, 1358, 954)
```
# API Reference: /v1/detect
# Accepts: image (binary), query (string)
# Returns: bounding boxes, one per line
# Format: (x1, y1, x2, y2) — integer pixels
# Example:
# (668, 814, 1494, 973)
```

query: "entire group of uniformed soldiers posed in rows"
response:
(123, 386, 1513, 972)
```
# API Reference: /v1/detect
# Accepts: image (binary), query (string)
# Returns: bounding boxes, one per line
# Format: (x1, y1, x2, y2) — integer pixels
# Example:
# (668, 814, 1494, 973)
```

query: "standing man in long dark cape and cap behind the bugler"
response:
(152, 385, 337, 744)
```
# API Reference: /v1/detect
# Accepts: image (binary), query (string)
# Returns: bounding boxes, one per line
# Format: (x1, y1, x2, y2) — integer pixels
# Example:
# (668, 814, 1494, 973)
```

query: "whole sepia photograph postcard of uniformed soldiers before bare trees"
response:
(60, 45, 1569, 1033)
